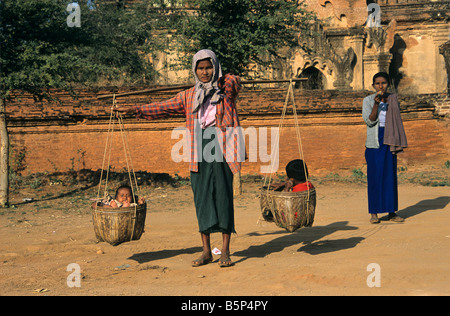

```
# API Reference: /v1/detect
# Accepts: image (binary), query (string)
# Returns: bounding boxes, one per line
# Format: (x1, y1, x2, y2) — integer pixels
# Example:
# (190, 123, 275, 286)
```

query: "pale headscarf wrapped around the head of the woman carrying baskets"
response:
(192, 49, 223, 113)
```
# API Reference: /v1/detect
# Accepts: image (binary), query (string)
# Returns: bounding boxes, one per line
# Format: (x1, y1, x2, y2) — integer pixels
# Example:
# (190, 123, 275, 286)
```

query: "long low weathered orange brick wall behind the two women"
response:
(7, 89, 450, 176)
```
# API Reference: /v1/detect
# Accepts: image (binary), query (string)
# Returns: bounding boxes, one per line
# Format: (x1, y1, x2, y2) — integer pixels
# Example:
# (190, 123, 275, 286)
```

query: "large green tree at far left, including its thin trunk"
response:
(0, 0, 161, 207)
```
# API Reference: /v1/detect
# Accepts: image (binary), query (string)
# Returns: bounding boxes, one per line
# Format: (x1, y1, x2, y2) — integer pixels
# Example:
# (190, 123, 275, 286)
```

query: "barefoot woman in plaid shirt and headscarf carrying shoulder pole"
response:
(116, 49, 241, 267)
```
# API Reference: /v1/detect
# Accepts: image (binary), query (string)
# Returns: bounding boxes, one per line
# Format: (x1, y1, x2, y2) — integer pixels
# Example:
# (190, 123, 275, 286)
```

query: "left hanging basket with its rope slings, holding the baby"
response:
(92, 97, 147, 246)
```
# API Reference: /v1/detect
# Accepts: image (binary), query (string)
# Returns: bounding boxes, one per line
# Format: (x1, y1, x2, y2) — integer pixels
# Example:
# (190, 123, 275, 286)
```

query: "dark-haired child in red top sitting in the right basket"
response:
(271, 159, 314, 192)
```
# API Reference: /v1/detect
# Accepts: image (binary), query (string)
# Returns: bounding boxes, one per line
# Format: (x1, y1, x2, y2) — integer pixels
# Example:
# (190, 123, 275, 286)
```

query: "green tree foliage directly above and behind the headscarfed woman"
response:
(171, 0, 314, 75)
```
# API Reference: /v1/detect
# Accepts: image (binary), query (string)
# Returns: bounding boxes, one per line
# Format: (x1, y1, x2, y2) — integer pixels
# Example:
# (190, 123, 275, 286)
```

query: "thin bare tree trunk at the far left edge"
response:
(0, 98, 9, 207)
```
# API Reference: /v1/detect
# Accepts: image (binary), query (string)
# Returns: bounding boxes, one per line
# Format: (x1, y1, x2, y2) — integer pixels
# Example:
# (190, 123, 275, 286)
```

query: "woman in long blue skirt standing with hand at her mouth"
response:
(362, 72, 408, 224)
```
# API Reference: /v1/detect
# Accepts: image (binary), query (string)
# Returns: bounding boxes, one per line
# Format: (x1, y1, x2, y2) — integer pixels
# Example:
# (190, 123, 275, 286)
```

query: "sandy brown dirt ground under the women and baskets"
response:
(0, 175, 450, 296)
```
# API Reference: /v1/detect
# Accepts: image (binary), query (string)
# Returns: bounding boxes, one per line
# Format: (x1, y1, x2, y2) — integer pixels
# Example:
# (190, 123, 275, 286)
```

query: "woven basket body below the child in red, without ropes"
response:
(260, 187, 316, 233)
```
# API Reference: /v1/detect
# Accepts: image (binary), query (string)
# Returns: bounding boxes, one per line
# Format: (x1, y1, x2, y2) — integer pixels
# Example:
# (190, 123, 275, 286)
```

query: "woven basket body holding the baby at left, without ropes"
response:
(92, 203, 147, 246)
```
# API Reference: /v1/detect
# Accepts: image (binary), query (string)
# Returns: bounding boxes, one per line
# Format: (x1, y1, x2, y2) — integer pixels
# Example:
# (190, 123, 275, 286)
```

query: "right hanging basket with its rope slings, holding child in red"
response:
(260, 81, 316, 233)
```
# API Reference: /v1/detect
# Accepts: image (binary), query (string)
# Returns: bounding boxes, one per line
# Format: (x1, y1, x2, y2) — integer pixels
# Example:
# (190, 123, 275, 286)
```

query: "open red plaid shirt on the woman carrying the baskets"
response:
(134, 74, 242, 174)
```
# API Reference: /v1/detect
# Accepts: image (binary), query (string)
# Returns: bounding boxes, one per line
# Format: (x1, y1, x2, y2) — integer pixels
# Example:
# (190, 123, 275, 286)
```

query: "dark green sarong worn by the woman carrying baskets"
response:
(191, 127, 235, 234)
